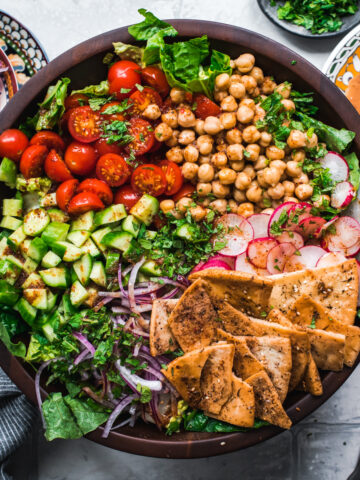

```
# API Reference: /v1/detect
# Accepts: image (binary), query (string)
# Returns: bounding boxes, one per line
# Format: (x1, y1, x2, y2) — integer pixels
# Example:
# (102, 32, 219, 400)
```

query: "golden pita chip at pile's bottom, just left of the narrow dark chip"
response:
(205, 374, 255, 427)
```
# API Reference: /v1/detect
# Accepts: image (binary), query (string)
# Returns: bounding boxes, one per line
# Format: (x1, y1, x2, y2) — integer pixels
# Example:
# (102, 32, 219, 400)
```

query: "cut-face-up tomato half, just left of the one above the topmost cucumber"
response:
(96, 153, 130, 187)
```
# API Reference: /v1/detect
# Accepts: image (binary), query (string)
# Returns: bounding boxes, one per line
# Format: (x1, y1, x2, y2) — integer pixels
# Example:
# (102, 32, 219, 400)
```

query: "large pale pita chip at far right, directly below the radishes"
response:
(269, 259, 359, 325)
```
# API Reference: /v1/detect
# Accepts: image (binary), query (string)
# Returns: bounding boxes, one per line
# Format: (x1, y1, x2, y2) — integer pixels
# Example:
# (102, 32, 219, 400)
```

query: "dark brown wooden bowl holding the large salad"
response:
(0, 20, 360, 458)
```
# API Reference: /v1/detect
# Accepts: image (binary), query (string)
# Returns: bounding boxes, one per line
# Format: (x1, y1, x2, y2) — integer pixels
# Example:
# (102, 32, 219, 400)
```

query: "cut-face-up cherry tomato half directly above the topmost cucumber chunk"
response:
(131, 163, 166, 197)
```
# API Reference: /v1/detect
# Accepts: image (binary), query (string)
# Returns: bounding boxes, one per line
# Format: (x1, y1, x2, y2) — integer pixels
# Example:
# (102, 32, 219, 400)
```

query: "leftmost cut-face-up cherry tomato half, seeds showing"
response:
(68, 106, 101, 143)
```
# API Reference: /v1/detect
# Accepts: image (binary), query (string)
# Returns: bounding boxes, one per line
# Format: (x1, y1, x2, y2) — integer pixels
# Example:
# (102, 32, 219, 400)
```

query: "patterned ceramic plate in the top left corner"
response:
(0, 10, 49, 88)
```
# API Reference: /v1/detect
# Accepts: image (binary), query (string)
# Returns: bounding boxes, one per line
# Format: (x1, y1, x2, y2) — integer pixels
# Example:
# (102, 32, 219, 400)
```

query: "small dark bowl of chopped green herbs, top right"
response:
(258, 0, 360, 38)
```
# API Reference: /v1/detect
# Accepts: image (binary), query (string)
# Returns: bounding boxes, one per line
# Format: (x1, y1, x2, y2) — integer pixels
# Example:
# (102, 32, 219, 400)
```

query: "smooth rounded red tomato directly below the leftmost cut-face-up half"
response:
(64, 142, 98, 175)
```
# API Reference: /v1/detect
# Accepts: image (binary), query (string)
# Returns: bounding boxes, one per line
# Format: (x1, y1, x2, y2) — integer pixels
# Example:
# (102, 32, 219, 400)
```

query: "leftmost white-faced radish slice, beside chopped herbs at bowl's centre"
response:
(218, 213, 254, 257)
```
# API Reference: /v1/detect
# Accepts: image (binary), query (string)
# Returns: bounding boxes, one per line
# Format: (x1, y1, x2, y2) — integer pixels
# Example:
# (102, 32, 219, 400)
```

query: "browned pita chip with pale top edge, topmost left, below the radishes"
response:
(189, 268, 272, 316)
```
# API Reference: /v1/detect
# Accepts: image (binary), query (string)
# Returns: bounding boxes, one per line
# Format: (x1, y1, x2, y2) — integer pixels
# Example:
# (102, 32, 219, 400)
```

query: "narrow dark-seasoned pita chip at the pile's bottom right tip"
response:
(246, 372, 291, 428)
